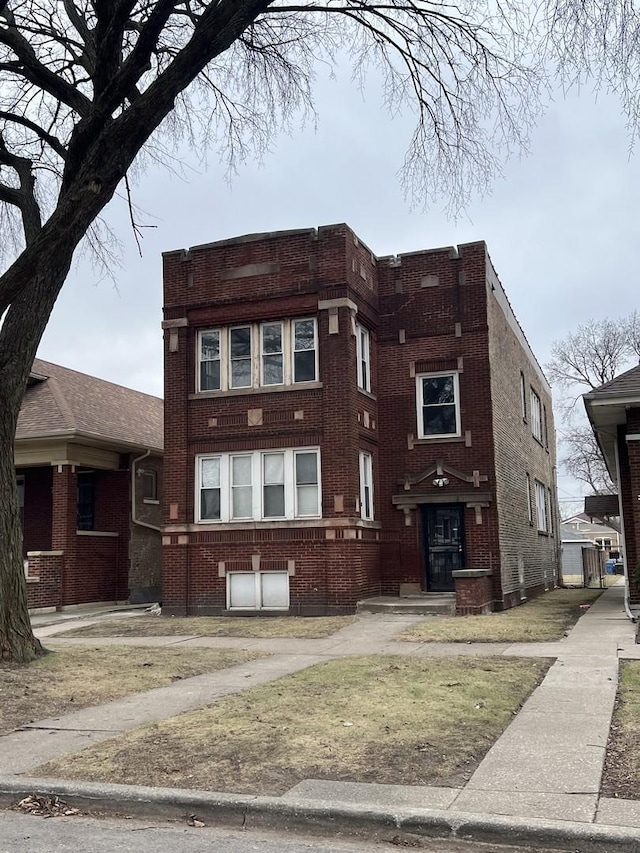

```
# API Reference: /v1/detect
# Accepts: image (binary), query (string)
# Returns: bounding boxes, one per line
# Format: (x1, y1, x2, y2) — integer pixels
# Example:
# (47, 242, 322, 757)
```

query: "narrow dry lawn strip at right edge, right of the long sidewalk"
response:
(601, 661, 640, 800)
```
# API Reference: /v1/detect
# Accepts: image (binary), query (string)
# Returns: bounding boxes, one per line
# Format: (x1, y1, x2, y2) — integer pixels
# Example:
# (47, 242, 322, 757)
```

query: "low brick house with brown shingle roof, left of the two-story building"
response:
(14, 359, 163, 609)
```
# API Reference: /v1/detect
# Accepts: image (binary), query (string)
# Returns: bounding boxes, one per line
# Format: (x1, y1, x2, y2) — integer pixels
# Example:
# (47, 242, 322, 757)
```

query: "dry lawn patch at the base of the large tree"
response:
(0, 646, 260, 735)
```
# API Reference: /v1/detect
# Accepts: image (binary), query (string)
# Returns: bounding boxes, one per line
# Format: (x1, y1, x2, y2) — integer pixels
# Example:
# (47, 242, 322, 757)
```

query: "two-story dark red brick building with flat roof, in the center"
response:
(163, 225, 559, 614)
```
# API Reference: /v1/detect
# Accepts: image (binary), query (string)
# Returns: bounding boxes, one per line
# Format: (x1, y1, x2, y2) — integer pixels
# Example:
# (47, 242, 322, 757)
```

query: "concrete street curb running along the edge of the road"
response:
(0, 776, 640, 853)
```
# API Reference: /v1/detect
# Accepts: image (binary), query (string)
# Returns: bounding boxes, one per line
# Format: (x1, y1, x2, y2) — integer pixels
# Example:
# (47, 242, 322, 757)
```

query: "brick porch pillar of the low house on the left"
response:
(51, 465, 78, 605)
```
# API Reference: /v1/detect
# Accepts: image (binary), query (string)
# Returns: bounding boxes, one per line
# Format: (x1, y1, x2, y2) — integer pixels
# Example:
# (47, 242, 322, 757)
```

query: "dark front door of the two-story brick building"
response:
(422, 504, 464, 592)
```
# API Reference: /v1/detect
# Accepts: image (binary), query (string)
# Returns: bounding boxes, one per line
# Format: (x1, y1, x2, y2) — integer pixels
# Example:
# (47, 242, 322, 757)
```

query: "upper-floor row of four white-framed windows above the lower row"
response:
(197, 317, 318, 391)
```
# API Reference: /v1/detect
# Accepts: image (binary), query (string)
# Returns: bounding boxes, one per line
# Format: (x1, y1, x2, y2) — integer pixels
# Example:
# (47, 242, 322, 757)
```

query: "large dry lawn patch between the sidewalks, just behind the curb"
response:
(34, 656, 550, 795)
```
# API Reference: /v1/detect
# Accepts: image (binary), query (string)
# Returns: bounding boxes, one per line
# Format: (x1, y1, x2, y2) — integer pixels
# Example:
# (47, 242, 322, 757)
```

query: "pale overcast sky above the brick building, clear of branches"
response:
(39, 66, 640, 512)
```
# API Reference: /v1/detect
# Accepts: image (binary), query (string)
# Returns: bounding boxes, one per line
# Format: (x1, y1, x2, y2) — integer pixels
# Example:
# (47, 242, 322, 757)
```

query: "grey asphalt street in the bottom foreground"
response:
(0, 811, 573, 853)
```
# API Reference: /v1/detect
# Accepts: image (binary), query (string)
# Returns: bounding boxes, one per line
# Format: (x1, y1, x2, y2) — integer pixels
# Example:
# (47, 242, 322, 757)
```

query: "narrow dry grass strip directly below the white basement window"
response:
(56, 616, 353, 639)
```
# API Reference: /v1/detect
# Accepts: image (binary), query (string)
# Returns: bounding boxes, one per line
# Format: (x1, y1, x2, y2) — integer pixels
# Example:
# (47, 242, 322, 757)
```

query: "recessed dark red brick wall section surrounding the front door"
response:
(378, 243, 499, 595)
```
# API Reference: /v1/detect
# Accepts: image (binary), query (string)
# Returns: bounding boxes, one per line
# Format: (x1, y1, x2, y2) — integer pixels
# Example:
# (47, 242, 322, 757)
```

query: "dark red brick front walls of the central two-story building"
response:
(163, 225, 551, 613)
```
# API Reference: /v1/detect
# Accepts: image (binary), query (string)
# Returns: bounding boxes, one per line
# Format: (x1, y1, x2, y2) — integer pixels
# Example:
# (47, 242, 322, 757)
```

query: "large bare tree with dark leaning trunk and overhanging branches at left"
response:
(0, 0, 637, 661)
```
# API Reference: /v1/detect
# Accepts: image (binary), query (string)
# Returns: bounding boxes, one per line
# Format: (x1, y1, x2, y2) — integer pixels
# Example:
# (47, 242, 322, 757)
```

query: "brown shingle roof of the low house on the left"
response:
(16, 359, 164, 450)
